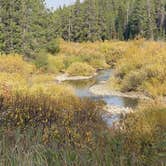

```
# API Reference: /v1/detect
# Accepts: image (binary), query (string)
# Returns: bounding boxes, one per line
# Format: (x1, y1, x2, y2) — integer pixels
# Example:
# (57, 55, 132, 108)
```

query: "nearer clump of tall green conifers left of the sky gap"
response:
(0, 0, 55, 56)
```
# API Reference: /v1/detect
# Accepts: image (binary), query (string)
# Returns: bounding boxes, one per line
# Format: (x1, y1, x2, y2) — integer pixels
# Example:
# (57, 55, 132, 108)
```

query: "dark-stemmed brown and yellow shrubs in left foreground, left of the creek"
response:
(0, 82, 102, 146)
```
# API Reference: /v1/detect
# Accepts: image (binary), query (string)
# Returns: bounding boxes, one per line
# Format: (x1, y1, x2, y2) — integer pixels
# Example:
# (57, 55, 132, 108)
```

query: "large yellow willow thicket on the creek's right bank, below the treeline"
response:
(111, 40, 166, 97)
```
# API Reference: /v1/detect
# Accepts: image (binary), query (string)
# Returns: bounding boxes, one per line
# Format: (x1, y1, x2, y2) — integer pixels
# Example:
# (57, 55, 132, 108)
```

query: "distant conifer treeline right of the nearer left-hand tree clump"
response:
(54, 0, 166, 42)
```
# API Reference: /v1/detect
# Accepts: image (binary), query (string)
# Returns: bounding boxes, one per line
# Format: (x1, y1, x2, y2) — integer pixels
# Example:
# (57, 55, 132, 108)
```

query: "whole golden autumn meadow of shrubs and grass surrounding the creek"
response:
(0, 39, 166, 166)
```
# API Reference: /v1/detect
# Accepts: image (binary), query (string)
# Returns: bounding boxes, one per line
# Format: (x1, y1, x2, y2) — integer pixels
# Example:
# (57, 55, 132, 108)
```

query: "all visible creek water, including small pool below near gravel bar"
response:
(65, 69, 138, 126)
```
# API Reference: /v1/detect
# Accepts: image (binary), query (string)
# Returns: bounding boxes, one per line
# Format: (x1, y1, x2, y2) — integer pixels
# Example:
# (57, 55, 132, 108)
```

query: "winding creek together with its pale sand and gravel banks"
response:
(56, 69, 140, 126)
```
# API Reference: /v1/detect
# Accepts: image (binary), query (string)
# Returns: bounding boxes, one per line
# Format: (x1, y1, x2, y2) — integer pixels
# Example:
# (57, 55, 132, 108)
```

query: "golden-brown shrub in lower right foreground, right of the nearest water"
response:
(123, 101, 166, 159)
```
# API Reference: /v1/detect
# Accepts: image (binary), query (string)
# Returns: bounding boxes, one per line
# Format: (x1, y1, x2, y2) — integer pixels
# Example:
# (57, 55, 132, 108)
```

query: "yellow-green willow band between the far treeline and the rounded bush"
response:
(42, 40, 128, 73)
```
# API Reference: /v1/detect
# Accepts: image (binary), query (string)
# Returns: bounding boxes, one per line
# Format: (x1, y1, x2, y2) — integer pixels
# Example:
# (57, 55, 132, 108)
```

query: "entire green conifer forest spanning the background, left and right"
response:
(0, 0, 166, 57)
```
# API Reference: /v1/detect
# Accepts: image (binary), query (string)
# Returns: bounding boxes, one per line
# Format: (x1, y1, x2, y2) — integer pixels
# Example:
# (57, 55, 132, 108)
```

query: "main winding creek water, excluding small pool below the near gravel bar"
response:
(66, 69, 138, 108)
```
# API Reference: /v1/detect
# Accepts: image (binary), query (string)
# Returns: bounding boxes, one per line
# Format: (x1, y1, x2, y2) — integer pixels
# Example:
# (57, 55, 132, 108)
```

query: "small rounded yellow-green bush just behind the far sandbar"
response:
(67, 62, 95, 76)
